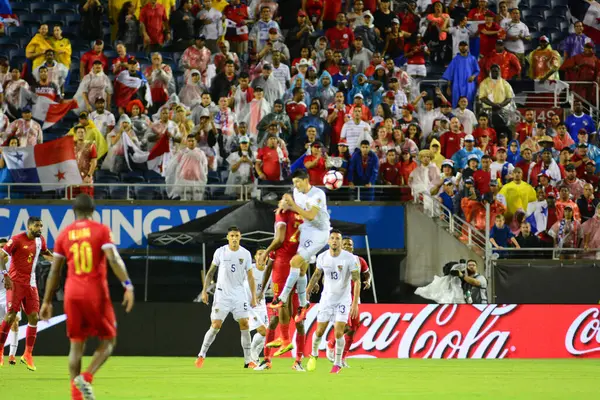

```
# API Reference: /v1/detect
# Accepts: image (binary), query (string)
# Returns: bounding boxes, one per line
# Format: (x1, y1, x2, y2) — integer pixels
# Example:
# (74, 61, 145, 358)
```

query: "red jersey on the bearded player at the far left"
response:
(2, 232, 48, 287)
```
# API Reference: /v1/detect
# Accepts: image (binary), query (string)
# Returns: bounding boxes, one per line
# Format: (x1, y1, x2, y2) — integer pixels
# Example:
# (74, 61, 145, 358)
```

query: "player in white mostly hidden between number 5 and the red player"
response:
(245, 247, 269, 364)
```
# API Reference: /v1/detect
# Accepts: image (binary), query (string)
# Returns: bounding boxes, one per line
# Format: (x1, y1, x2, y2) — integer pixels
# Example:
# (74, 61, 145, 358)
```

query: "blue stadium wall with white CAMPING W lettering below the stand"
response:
(0, 202, 405, 250)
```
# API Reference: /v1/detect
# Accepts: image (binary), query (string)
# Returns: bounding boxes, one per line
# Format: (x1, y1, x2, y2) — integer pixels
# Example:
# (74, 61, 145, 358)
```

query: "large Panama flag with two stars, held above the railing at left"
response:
(1, 136, 81, 191)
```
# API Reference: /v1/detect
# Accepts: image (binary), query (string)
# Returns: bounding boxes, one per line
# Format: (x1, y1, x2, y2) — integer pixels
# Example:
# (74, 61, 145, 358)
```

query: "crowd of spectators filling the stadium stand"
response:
(0, 0, 600, 248)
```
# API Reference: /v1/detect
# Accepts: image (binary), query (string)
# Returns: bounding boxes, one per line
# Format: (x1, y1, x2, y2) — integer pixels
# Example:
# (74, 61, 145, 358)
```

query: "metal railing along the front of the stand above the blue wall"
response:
(0, 183, 410, 202)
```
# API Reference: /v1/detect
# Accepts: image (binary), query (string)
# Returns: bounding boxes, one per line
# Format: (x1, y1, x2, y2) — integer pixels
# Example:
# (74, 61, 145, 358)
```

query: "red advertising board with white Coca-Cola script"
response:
(292, 304, 600, 358)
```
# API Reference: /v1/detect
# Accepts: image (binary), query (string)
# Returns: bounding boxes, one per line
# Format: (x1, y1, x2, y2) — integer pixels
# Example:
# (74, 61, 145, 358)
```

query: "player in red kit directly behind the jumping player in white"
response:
(255, 203, 305, 371)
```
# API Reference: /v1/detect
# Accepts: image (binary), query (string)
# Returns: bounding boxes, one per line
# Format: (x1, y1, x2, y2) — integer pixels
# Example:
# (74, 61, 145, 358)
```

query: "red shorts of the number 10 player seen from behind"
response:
(65, 297, 117, 342)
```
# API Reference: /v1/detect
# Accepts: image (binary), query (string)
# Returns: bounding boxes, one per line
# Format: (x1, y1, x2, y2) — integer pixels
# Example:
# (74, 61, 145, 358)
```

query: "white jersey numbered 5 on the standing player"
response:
(212, 245, 252, 298)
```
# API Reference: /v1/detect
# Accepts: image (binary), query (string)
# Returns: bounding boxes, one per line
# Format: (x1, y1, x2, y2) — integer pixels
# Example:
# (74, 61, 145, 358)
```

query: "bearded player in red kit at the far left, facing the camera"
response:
(0, 217, 52, 371)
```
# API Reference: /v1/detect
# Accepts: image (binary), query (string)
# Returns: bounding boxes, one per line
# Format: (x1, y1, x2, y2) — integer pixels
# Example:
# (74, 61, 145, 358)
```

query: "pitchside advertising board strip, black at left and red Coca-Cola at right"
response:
(25, 303, 600, 359)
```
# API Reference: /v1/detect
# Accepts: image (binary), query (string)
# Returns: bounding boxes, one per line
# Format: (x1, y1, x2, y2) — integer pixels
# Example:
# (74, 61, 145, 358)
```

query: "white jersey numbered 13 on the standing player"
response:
(317, 250, 360, 304)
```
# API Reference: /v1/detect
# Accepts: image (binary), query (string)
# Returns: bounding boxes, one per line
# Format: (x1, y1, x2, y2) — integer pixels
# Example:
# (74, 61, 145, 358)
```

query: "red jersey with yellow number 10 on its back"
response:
(54, 220, 114, 299)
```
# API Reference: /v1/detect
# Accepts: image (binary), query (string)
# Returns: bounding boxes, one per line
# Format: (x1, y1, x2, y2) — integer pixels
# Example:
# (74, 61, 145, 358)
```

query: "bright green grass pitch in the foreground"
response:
(0, 357, 600, 400)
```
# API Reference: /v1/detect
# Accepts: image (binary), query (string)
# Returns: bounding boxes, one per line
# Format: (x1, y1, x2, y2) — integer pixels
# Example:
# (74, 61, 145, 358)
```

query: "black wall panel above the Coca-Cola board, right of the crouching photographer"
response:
(493, 260, 600, 304)
